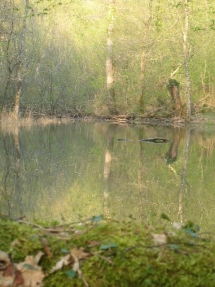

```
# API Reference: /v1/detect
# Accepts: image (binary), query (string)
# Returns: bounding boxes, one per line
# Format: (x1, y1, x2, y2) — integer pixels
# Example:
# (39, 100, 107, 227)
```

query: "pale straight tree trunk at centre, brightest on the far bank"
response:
(106, 0, 116, 114)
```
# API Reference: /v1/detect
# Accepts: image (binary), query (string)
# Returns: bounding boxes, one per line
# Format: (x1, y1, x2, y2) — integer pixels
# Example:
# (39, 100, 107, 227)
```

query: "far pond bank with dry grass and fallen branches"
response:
(0, 113, 215, 130)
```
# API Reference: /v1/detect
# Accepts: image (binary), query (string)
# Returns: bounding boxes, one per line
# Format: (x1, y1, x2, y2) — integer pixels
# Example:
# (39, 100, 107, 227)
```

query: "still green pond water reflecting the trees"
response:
(0, 122, 215, 229)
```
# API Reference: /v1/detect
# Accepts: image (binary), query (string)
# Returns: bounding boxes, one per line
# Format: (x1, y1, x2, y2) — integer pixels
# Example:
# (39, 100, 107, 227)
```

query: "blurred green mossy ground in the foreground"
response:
(0, 216, 215, 287)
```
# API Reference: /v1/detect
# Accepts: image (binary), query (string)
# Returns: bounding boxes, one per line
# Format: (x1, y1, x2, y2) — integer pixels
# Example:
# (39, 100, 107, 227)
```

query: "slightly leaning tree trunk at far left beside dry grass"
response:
(14, 0, 29, 121)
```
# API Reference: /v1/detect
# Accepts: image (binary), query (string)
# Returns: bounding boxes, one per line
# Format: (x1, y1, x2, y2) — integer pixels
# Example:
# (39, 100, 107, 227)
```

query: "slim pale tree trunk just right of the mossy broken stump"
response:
(183, 0, 191, 121)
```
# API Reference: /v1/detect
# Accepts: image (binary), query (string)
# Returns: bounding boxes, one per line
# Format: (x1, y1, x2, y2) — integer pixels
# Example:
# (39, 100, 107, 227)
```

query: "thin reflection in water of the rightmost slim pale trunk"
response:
(178, 127, 190, 222)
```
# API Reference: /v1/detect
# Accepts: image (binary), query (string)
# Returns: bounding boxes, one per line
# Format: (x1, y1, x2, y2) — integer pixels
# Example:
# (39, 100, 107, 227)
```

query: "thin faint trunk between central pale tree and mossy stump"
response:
(139, 0, 153, 113)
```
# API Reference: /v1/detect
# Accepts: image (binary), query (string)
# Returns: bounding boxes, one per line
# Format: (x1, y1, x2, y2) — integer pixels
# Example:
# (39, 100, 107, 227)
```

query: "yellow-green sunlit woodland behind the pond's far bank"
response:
(0, 0, 215, 116)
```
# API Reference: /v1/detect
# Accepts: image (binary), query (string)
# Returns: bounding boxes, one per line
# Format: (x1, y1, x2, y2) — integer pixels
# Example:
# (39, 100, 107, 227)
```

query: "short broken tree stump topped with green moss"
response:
(167, 79, 182, 116)
